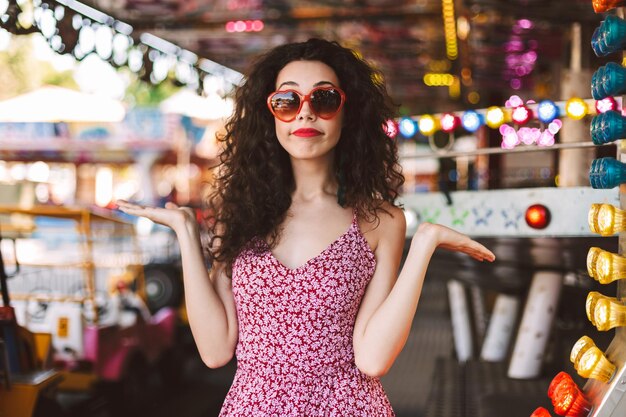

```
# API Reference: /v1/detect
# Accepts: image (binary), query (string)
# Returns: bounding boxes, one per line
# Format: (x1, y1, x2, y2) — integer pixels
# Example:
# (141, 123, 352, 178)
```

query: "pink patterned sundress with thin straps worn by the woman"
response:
(220, 211, 395, 417)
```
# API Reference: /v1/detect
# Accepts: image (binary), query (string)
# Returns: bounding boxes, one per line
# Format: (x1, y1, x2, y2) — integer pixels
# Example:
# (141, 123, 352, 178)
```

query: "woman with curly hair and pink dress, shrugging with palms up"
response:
(119, 39, 495, 417)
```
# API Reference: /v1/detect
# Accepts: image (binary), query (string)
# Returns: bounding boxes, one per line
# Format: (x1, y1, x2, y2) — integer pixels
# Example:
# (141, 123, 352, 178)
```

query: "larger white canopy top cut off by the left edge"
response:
(0, 86, 126, 123)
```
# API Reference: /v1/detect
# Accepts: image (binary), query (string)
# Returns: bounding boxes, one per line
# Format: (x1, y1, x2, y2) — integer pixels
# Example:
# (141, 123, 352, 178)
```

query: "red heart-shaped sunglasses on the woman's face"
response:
(267, 87, 346, 122)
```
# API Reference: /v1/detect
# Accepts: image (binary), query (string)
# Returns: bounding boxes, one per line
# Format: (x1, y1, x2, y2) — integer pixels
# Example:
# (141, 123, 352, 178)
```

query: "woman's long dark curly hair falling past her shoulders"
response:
(208, 39, 404, 271)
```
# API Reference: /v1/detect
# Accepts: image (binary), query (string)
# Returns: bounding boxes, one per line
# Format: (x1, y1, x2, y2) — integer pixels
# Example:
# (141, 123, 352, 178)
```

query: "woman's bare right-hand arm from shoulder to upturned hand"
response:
(354, 207, 495, 376)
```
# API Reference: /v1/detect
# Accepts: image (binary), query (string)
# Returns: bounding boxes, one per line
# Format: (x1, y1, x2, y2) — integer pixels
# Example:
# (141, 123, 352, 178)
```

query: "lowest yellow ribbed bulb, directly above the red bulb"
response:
(570, 336, 615, 382)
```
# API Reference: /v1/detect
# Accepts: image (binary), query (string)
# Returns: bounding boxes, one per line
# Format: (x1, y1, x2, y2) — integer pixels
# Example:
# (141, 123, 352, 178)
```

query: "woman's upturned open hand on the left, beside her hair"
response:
(116, 200, 197, 234)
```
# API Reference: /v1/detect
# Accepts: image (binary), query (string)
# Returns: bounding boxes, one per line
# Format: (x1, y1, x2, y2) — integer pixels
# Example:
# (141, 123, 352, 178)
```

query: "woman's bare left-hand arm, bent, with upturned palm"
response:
(118, 201, 238, 368)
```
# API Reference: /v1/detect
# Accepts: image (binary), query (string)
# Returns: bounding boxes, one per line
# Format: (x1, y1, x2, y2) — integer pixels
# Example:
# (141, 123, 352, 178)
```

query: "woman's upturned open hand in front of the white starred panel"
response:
(413, 223, 496, 262)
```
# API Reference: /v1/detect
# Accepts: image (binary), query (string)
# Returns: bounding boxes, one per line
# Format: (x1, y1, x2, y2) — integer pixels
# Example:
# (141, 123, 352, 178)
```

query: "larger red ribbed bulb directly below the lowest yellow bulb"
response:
(548, 372, 591, 417)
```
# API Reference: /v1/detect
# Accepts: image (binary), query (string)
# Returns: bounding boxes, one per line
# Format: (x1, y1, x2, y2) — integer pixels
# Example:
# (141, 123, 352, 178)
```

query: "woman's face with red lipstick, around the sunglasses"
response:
(274, 61, 343, 159)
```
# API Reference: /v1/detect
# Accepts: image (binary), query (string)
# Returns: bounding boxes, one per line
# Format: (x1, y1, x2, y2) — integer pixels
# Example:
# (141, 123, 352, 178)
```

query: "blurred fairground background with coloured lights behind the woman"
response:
(0, 0, 626, 417)
